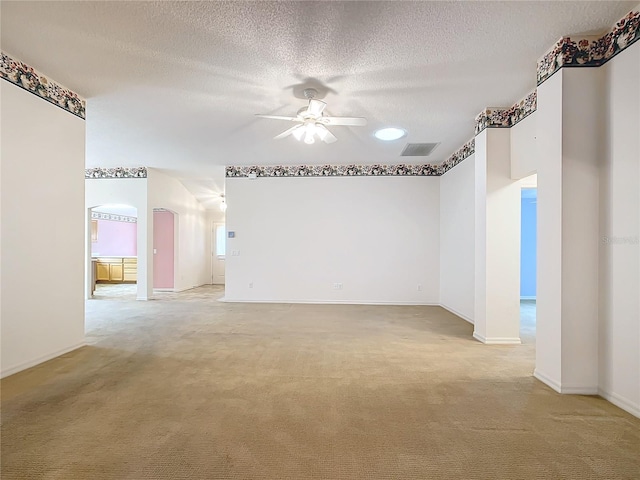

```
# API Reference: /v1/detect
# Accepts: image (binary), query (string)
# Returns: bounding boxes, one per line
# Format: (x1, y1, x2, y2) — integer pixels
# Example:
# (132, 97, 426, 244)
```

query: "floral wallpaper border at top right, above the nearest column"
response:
(537, 7, 640, 85)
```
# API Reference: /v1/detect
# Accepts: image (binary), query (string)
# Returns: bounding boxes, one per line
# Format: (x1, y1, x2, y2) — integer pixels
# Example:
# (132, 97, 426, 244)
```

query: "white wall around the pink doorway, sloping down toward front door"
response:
(147, 168, 211, 291)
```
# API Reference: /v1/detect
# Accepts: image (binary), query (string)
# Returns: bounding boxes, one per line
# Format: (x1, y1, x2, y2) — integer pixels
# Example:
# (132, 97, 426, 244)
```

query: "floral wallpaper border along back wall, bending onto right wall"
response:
(225, 139, 475, 178)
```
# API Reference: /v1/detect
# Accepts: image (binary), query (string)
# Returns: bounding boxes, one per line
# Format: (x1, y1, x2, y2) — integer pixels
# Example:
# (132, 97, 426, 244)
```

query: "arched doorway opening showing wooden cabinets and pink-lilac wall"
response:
(87, 204, 138, 299)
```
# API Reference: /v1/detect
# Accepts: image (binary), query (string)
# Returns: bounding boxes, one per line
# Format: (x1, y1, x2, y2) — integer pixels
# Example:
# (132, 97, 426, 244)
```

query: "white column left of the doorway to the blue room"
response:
(473, 128, 520, 344)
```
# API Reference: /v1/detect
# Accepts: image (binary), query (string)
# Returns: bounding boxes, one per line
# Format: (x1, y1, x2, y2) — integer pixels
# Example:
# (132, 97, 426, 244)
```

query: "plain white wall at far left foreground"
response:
(0, 81, 85, 376)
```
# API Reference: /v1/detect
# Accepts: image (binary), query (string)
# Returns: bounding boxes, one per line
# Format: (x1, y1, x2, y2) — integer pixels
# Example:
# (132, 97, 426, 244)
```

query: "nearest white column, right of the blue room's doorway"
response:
(534, 68, 604, 394)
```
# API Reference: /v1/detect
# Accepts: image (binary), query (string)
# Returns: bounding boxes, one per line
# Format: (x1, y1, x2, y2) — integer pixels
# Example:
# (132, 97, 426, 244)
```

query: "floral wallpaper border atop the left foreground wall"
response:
(0, 52, 86, 120)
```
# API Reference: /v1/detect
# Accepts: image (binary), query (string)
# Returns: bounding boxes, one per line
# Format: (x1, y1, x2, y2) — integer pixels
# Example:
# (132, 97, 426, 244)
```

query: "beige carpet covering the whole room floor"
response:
(1, 287, 640, 480)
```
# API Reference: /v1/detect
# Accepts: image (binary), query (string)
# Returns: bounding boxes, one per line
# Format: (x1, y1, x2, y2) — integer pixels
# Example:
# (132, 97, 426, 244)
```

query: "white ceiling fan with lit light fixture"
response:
(256, 88, 367, 144)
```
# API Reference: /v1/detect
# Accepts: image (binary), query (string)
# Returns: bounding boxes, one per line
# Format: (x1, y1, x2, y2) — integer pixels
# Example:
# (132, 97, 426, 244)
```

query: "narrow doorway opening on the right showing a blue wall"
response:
(520, 179, 538, 342)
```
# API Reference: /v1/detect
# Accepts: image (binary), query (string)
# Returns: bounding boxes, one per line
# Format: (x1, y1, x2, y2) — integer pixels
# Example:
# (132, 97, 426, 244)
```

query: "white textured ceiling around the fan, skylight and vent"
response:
(0, 1, 637, 206)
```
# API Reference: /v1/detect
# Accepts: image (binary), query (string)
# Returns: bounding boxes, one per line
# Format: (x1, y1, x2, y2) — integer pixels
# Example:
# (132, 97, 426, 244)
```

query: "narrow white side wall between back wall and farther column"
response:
(440, 155, 475, 323)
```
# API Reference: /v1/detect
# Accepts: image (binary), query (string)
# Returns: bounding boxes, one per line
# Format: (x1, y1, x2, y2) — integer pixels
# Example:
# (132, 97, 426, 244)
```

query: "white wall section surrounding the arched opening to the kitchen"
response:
(85, 178, 153, 300)
